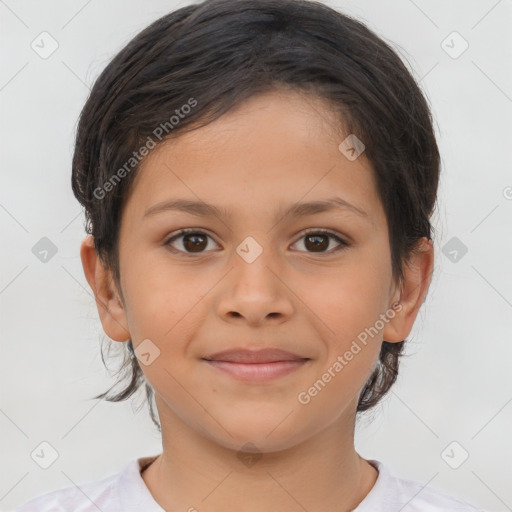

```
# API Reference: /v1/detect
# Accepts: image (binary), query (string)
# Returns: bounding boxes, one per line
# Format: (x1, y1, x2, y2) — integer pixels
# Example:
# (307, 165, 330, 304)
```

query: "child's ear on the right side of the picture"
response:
(383, 237, 434, 343)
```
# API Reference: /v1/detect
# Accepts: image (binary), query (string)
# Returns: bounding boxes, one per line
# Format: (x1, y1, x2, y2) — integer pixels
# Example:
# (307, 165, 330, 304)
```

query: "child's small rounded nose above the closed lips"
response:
(217, 245, 295, 326)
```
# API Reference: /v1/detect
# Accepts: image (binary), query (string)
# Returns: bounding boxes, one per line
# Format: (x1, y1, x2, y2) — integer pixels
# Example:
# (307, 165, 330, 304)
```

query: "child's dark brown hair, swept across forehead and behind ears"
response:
(72, 0, 440, 430)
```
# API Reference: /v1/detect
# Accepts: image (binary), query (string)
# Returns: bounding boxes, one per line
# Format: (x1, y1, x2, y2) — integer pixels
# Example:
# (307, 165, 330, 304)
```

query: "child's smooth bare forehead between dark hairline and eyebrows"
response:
(120, 91, 383, 229)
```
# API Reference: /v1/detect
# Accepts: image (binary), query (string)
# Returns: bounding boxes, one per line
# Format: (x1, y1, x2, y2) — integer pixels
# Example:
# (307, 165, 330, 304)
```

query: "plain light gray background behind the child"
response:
(0, 0, 512, 511)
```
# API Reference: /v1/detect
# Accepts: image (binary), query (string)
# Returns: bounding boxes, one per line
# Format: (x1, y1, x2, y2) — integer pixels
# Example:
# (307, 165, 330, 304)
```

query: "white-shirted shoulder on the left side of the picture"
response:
(13, 459, 142, 512)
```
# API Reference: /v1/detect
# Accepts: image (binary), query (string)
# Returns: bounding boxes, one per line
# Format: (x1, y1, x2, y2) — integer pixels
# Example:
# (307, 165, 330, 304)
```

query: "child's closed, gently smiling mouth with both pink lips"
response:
(202, 349, 311, 382)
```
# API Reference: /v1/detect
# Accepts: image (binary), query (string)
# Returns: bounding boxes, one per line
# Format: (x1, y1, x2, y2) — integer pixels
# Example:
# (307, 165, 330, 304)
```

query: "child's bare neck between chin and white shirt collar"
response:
(142, 402, 378, 512)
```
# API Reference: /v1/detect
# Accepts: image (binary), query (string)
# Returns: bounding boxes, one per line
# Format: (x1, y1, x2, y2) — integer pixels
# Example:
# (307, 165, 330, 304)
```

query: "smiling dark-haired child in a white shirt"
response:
(11, 0, 480, 512)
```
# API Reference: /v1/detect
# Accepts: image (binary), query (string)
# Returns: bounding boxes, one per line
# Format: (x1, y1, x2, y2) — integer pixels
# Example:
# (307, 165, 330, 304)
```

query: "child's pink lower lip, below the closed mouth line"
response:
(205, 359, 308, 382)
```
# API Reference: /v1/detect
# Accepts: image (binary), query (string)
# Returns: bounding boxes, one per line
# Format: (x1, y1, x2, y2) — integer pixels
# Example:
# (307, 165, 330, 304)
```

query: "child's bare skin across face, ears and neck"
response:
(81, 90, 433, 512)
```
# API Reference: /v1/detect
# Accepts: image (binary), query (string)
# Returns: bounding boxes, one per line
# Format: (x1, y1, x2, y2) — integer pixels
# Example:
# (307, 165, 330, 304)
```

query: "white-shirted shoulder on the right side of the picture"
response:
(354, 460, 484, 512)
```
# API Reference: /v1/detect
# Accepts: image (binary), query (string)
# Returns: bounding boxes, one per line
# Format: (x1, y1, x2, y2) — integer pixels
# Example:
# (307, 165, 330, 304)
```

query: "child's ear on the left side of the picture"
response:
(80, 235, 130, 341)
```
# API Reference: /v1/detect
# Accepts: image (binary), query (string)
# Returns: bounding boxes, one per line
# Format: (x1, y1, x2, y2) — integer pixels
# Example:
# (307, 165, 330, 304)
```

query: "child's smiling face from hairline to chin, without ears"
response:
(91, 91, 403, 452)
